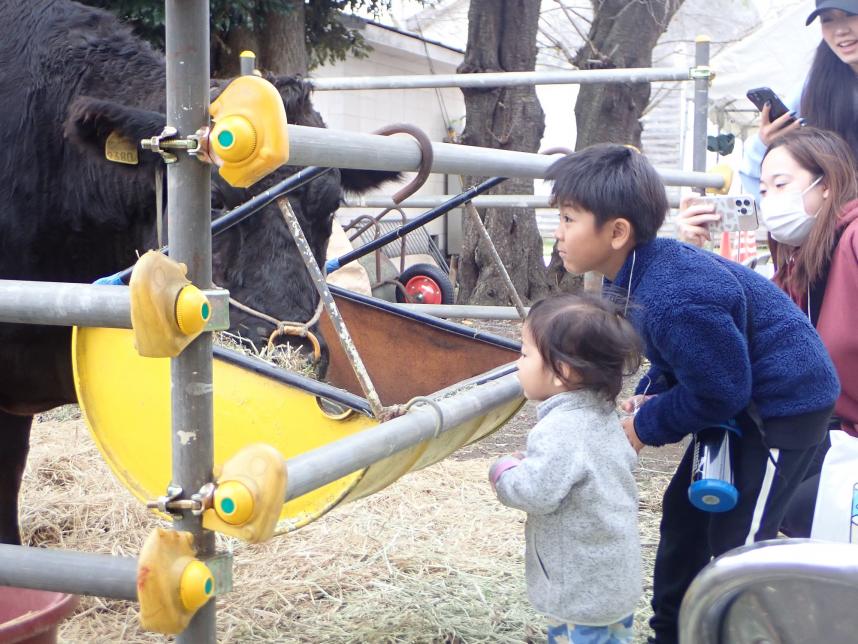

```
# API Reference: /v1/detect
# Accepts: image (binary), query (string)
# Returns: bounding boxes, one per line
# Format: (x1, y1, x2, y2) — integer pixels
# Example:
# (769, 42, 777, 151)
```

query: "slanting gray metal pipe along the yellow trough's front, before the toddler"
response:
(285, 373, 522, 501)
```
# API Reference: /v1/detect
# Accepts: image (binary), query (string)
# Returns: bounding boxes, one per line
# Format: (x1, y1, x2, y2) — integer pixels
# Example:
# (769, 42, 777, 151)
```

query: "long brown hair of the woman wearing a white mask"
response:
(763, 127, 858, 297)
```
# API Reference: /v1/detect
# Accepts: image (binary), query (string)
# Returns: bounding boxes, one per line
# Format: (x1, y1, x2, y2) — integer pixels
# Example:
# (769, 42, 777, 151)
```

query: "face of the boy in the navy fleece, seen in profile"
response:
(554, 203, 628, 279)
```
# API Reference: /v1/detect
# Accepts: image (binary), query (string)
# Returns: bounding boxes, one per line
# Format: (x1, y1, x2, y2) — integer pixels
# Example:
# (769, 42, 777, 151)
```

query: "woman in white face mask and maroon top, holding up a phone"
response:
(681, 128, 858, 537)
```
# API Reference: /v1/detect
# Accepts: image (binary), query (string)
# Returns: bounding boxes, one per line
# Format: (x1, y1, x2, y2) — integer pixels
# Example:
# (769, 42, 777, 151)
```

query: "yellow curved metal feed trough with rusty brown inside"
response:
(72, 290, 524, 533)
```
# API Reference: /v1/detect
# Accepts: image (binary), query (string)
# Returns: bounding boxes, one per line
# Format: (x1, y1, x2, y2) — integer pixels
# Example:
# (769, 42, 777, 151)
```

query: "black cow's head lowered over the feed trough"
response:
(65, 77, 398, 370)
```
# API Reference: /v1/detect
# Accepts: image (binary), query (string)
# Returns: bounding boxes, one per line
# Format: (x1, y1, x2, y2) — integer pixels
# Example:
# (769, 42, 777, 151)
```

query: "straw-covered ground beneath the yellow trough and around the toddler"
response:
(21, 322, 681, 644)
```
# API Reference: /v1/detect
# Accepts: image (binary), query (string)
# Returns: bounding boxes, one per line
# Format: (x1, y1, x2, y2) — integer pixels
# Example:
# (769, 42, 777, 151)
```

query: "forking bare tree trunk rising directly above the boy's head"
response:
(575, 0, 683, 150)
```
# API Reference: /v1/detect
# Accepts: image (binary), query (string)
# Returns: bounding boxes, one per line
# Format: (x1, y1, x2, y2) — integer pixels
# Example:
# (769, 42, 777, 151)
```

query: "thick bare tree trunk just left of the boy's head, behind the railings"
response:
(458, 0, 548, 305)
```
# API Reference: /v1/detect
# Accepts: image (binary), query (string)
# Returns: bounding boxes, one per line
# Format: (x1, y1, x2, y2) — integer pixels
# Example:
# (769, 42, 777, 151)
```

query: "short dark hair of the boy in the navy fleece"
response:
(545, 143, 668, 242)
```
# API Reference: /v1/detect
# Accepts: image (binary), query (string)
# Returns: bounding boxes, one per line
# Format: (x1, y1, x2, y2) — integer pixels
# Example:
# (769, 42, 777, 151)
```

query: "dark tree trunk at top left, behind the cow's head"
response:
(212, 0, 309, 78)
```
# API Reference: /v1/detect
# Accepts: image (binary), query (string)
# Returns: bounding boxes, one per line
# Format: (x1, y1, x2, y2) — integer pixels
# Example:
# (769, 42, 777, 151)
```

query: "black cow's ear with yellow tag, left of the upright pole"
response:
(64, 96, 167, 165)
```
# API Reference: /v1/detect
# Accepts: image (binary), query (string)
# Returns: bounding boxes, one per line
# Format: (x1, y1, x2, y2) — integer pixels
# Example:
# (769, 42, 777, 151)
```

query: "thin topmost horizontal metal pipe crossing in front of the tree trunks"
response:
(307, 67, 692, 92)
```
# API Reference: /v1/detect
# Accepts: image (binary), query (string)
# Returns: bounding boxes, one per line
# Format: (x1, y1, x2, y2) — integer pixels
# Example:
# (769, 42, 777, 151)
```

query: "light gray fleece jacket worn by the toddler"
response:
(497, 390, 642, 626)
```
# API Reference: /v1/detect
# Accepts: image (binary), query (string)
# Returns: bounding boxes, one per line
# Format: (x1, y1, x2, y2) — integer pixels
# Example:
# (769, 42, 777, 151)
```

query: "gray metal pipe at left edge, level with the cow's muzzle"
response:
(0, 280, 131, 329)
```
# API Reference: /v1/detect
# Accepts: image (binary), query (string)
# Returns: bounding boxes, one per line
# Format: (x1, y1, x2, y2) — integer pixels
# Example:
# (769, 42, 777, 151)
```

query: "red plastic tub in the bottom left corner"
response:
(0, 586, 78, 644)
